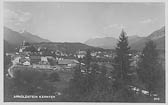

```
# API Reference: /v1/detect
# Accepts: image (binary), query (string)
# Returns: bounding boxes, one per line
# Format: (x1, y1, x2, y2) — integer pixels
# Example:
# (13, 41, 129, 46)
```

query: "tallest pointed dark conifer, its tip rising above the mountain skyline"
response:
(114, 30, 130, 83)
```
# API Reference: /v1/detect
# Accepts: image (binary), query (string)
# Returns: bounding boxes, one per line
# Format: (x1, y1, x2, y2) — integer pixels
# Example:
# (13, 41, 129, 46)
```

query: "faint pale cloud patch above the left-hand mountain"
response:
(4, 9, 32, 25)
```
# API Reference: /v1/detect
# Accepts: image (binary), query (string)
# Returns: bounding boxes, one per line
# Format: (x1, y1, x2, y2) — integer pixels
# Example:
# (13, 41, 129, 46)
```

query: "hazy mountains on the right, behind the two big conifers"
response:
(85, 26, 165, 50)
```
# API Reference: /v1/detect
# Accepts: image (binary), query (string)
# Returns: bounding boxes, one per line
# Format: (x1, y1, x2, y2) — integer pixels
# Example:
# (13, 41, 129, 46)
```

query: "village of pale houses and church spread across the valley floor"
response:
(6, 41, 140, 77)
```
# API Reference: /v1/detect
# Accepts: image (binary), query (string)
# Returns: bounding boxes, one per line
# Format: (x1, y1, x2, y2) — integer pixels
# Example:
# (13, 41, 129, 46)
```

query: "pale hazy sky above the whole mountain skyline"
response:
(4, 1, 165, 42)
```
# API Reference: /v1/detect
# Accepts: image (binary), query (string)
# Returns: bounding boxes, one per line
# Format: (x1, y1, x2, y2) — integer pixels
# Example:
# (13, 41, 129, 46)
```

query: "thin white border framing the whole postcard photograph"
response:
(0, 0, 168, 105)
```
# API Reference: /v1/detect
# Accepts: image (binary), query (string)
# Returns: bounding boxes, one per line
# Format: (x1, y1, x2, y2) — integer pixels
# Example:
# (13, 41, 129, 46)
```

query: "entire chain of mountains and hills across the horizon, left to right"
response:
(4, 26, 165, 52)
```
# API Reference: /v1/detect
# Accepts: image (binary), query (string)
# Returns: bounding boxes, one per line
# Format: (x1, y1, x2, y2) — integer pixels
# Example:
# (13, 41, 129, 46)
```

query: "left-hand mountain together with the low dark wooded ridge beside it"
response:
(4, 27, 102, 53)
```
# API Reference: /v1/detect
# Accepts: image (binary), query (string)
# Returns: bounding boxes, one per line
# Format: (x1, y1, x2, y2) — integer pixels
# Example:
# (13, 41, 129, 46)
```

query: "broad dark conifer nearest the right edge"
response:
(137, 40, 164, 99)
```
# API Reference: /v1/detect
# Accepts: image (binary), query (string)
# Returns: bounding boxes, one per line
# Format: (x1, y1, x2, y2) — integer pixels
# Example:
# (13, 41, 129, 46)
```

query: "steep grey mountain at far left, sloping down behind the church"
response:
(4, 27, 50, 52)
